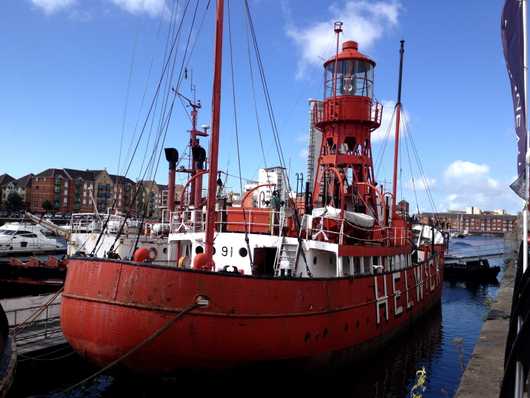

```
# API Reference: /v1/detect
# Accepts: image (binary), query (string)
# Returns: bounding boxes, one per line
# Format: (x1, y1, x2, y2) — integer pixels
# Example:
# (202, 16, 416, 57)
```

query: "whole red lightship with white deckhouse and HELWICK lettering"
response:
(61, 0, 445, 375)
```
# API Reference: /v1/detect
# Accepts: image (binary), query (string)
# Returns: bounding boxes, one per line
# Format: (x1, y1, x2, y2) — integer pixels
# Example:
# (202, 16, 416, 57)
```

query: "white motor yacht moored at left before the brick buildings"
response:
(0, 222, 66, 257)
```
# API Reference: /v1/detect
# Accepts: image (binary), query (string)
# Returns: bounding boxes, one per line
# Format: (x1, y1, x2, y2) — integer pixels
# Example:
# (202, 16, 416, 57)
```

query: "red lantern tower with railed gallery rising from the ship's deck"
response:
(313, 22, 385, 224)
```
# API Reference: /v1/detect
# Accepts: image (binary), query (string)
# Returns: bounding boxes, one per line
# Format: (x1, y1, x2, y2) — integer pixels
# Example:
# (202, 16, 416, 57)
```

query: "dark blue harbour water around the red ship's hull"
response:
(6, 237, 504, 398)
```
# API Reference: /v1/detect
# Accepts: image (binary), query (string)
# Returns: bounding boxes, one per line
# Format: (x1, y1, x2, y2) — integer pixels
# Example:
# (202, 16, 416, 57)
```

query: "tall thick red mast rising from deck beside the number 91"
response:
(201, 0, 224, 269)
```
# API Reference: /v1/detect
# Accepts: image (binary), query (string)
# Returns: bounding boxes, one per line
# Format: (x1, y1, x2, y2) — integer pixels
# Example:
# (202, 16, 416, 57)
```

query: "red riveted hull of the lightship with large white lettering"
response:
(61, 247, 443, 374)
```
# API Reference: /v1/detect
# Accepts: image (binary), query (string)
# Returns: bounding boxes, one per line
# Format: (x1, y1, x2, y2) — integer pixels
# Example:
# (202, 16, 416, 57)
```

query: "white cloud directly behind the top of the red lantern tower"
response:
(284, 0, 401, 78)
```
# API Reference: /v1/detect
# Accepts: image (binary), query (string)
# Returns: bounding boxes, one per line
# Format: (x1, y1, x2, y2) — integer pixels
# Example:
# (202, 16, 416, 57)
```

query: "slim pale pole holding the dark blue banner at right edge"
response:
(514, 0, 530, 398)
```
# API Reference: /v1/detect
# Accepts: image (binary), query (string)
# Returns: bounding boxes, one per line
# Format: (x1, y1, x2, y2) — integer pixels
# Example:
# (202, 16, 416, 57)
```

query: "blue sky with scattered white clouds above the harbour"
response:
(0, 0, 520, 215)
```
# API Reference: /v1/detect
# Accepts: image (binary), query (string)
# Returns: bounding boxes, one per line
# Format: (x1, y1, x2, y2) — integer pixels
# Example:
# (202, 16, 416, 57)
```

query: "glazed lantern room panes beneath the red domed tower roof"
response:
(324, 59, 374, 98)
